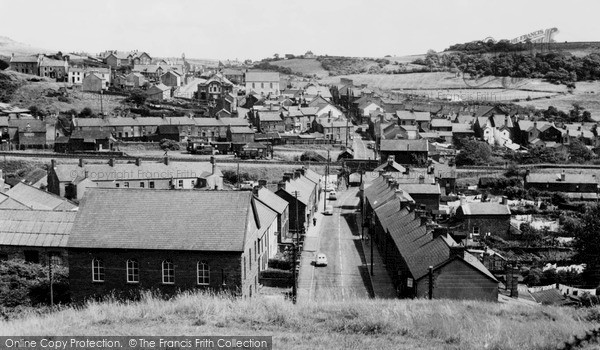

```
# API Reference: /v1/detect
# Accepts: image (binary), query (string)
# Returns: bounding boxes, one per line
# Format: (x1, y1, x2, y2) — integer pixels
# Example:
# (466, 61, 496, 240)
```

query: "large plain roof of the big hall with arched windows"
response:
(68, 188, 254, 252)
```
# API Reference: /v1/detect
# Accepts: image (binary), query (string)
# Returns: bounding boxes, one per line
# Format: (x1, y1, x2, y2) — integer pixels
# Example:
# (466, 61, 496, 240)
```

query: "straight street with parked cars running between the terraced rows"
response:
(302, 187, 371, 300)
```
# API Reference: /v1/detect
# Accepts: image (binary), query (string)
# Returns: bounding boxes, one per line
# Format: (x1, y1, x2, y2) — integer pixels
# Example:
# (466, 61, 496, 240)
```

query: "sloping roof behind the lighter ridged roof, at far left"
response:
(6, 182, 77, 210)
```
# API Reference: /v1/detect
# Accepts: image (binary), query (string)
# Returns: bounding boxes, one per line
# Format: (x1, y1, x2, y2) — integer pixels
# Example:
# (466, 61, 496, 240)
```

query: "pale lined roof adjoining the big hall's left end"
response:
(0, 209, 77, 247)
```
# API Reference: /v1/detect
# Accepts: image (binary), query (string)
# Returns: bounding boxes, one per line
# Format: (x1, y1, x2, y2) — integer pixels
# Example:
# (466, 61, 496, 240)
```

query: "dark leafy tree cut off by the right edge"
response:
(572, 204, 600, 287)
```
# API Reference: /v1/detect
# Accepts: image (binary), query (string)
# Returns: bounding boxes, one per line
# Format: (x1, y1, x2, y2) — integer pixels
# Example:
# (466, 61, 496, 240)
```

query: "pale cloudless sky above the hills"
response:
(0, 0, 600, 60)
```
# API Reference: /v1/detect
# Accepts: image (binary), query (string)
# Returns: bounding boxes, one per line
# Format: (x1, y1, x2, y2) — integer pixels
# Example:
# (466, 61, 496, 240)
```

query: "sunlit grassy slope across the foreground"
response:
(0, 294, 598, 350)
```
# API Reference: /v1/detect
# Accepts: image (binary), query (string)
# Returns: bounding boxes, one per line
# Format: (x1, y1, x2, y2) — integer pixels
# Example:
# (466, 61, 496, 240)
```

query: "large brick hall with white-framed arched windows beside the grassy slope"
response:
(67, 189, 277, 302)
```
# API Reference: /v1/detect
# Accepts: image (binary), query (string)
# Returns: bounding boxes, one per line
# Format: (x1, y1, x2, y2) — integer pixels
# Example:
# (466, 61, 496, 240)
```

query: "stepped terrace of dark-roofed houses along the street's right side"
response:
(361, 175, 502, 301)
